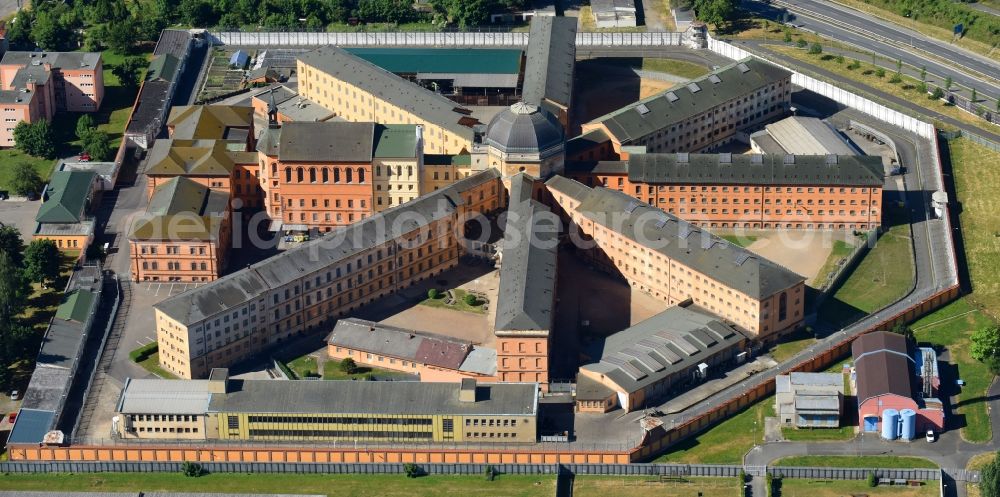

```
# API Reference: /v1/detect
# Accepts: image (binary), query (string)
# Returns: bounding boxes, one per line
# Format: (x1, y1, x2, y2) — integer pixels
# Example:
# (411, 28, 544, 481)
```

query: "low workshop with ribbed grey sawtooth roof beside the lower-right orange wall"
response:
(576, 306, 747, 412)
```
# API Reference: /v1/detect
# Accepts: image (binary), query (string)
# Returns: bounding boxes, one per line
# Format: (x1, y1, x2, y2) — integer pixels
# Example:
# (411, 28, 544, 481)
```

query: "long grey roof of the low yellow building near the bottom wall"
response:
(209, 379, 538, 416)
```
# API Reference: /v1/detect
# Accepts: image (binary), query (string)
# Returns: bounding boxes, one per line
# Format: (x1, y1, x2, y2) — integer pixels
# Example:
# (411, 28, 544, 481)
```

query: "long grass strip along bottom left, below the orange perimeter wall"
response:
(0, 472, 556, 497)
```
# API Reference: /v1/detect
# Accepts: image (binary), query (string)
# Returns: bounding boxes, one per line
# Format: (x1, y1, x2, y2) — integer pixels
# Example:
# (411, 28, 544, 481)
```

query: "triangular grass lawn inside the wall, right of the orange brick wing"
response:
(819, 204, 913, 326)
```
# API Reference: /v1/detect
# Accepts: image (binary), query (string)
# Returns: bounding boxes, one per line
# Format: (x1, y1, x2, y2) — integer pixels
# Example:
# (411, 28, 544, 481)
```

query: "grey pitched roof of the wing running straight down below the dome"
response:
(494, 173, 558, 334)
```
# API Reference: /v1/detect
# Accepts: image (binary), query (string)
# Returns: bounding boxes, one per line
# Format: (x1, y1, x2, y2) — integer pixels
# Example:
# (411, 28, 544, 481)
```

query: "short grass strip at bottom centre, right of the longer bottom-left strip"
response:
(573, 476, 740, 497)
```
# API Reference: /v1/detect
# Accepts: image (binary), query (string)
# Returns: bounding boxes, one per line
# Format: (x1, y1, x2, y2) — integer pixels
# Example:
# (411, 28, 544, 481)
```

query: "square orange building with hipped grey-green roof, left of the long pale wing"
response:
(128, 176, 232, 282)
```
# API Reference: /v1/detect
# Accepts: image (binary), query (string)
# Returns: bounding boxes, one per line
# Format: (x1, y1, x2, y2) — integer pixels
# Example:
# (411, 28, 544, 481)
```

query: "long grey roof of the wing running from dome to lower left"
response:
(153, 169, 500, 325)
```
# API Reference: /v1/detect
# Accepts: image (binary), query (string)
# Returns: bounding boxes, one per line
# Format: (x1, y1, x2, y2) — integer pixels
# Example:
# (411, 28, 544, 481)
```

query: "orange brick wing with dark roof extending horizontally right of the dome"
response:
(566, 153, 885, 230)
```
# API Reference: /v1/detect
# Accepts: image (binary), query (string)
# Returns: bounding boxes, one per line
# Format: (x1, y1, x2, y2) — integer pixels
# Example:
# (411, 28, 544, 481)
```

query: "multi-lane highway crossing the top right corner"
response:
(743, 0, 1000, 97)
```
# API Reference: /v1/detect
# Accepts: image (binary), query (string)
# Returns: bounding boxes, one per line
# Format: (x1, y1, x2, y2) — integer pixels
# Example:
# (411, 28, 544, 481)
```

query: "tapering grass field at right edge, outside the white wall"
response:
(948, 138, 1000, 319)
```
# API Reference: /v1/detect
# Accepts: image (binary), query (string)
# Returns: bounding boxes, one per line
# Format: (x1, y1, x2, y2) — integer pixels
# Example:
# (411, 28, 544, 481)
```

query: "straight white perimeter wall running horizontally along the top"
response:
(209, 31, 684, 48)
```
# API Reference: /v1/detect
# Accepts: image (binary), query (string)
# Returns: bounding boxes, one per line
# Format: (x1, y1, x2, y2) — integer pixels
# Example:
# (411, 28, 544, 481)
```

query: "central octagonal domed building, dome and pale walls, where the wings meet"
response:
(483, 102, 566, 179)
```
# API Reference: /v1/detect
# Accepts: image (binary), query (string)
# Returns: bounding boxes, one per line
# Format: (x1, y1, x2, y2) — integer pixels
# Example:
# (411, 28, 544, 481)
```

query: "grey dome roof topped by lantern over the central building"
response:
(486, 102, 563, 154)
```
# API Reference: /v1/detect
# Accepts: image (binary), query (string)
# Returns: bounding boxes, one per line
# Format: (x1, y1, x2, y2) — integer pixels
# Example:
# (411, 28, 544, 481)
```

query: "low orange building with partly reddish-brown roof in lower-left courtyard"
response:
(326, 318, 497, 382)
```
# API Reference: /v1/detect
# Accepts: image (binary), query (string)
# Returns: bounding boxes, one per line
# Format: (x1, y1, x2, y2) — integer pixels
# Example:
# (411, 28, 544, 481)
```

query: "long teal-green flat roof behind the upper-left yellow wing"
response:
(344, 48, 521, 74)
